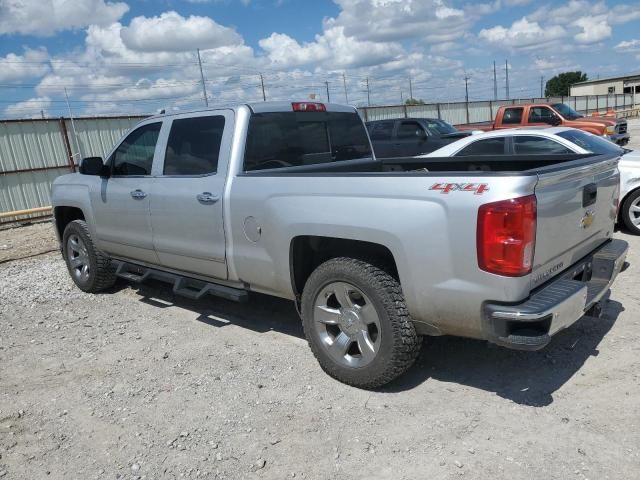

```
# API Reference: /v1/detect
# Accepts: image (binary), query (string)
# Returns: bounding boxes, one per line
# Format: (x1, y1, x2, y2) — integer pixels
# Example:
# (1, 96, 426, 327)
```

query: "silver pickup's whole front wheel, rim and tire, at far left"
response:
(62, 220, 116, 293)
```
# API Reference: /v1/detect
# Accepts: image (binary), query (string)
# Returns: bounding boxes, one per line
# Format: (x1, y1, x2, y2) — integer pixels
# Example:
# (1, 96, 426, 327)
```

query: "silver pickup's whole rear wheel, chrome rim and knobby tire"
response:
(302, 258, 422, 388)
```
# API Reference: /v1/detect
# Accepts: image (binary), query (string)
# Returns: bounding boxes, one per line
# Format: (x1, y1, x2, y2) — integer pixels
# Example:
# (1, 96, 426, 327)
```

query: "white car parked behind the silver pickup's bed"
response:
(421, 127, 640, 235)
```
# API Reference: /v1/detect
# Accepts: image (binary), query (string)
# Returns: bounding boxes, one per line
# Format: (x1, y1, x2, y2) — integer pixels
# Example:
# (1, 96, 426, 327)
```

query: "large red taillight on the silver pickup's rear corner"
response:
(476, 195, 537, 277)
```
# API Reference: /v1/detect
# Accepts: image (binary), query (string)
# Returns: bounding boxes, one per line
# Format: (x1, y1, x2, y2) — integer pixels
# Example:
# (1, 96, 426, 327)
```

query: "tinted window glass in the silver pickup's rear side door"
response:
(163, 115, 224, 175)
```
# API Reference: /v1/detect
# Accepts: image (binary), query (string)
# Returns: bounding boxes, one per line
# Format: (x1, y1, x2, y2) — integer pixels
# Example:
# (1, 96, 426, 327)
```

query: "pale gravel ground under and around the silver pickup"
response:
(0, 227, 640, 480)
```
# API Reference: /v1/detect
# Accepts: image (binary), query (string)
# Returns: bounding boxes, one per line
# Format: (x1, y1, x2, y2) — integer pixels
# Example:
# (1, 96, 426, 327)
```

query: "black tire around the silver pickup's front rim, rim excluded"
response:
(62, 220, 116, 293)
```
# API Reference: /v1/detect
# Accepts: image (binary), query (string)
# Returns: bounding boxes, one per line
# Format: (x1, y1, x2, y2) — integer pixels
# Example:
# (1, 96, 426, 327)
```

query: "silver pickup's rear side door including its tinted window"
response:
(150, 110, 234, 279)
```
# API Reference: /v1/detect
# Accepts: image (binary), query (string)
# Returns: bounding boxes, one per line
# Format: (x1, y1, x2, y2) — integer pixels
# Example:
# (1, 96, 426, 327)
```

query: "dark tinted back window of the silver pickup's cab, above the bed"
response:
(244, 112, 372, 171)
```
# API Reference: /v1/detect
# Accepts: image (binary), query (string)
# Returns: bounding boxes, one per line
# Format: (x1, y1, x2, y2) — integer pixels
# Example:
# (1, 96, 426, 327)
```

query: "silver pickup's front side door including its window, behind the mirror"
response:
(91, 122, 162, 263)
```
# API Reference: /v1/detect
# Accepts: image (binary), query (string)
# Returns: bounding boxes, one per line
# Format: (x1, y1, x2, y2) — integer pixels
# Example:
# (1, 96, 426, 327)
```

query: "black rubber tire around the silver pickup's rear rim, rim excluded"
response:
(302, 258, 422, 389)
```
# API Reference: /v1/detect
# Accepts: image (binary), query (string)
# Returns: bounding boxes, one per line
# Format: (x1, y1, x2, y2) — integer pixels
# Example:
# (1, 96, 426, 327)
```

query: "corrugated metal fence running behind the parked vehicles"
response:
(0, 94, 634, 223)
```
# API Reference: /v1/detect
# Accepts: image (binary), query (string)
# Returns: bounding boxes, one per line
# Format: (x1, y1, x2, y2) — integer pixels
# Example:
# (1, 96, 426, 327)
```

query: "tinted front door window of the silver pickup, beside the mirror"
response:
(111, 122, 162, 176)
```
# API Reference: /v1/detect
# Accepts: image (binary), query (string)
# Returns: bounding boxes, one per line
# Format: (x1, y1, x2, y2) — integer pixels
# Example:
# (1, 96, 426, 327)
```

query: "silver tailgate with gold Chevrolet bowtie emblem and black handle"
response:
(531, 157, 619, 288)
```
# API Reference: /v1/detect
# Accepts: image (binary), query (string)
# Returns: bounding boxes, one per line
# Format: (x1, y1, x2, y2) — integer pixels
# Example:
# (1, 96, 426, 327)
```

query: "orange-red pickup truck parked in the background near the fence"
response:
(456, 103, 630, 145)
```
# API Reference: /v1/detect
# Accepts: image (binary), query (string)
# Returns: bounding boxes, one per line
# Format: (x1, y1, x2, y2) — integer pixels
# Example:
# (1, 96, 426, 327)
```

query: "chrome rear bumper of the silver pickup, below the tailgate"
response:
(485, 240, 628, 350)
